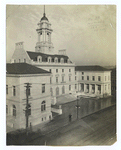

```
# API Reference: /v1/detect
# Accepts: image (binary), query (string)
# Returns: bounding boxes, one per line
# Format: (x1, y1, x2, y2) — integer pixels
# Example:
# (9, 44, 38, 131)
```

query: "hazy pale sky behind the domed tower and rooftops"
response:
(6, 5, 116, 66)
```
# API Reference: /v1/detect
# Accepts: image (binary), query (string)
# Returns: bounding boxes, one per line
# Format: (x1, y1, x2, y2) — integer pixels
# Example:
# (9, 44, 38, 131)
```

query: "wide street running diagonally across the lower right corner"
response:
(28, 105, 116, 146)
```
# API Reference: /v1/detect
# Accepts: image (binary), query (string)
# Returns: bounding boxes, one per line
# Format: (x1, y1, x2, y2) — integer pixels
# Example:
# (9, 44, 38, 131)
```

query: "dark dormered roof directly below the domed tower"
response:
(27, 51, 69, 61)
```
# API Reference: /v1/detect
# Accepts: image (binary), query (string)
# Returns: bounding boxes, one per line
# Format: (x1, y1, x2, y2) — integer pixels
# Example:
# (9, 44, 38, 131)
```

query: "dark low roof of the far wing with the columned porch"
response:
(75, 65, 110, 71)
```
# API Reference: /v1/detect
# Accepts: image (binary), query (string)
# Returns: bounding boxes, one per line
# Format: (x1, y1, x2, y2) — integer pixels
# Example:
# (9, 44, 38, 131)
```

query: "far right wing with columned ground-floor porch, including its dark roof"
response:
(75, 66, 111, 96)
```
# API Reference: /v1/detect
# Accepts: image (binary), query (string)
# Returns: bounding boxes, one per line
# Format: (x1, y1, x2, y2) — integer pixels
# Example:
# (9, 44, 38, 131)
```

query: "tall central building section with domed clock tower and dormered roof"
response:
(11, 10, 75, 98)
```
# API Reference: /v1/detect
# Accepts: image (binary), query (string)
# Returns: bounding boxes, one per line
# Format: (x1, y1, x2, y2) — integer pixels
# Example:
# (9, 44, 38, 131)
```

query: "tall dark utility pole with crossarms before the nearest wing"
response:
(25, 83, 31, 135)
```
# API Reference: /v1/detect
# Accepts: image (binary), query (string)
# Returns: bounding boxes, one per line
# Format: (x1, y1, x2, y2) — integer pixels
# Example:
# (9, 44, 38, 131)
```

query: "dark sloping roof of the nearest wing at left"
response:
(6, 63, 50, 74)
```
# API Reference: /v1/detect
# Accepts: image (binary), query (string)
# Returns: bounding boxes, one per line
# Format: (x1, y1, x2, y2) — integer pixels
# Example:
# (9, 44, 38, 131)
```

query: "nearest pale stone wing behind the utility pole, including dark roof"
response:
(6, 63, 52, 129)
